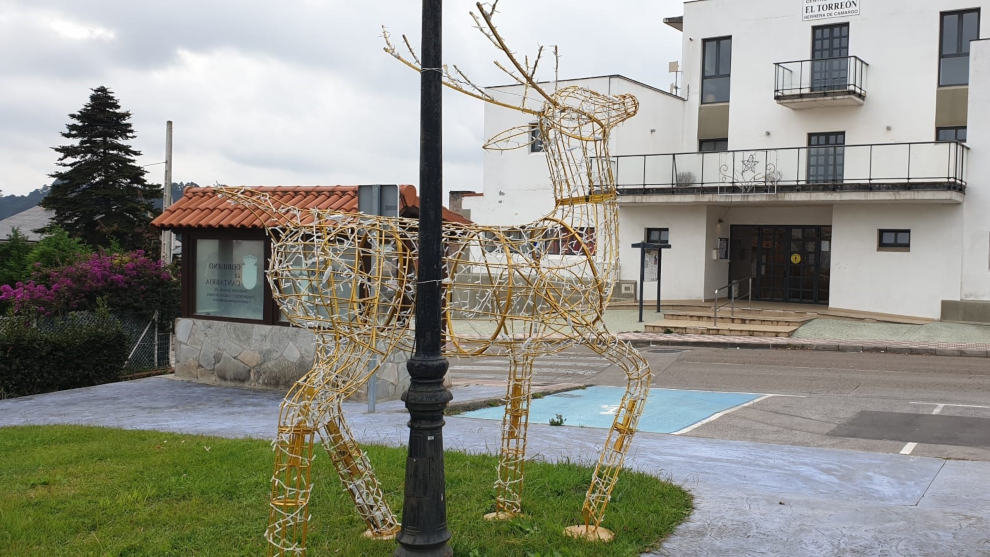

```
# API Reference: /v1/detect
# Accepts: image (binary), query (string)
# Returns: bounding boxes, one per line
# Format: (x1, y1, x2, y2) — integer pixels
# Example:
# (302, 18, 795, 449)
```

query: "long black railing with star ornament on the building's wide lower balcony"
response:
(612, 141, 969, 195)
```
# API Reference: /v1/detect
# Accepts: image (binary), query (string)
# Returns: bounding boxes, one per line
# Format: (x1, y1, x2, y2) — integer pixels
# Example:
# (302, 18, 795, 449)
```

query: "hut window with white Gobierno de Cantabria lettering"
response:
(193, 238, 265, 320)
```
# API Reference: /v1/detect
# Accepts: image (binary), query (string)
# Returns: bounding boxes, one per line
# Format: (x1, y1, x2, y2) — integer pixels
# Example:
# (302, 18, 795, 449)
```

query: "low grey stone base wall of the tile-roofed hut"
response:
(175, 318, 409, 401)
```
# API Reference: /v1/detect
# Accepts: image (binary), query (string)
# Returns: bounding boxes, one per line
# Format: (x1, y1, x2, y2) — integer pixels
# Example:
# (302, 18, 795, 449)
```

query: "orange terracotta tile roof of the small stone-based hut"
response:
(151, 185, 471, 229)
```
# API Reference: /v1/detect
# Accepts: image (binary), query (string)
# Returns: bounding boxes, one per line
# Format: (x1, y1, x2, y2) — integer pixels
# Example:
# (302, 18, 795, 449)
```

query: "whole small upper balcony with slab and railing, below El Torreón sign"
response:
(773, 56, 870, 110)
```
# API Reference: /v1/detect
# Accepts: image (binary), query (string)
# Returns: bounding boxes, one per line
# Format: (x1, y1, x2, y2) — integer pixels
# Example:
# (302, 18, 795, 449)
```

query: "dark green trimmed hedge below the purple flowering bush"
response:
(0, 311, 128, 398)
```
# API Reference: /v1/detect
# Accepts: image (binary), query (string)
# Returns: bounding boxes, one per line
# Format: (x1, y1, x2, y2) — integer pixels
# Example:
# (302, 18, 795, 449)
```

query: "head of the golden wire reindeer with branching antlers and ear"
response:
(382, 0, 639, 150)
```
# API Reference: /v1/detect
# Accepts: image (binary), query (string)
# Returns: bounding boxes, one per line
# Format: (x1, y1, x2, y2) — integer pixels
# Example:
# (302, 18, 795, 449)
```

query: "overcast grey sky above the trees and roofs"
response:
(0, 0, 682, 194)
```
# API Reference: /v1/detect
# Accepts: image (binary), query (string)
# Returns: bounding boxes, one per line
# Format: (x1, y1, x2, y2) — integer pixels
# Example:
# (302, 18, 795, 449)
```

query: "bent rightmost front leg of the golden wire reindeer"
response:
(566, 331, 653, 541)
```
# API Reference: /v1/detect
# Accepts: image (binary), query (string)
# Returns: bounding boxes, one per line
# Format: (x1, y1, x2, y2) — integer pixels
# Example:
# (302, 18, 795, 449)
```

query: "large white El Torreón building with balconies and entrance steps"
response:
(465, 0, 990, 320)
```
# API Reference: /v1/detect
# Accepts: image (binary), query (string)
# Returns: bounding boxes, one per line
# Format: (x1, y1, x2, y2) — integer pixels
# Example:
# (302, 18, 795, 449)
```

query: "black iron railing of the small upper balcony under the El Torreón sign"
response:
(773, 56, 870, 100)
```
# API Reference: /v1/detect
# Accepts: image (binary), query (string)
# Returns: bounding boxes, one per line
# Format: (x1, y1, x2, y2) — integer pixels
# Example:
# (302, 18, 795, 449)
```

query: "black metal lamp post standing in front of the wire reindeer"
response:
(395, 0, 452, 557)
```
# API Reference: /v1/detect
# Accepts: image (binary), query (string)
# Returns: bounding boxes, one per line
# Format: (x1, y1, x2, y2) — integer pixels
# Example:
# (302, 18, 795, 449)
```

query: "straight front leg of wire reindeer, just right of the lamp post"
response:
(485, 353, 533, 520)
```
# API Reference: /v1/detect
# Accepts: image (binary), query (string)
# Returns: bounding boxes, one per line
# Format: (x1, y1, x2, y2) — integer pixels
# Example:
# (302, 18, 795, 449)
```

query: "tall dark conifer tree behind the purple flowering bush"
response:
(41, 86, 161, 251)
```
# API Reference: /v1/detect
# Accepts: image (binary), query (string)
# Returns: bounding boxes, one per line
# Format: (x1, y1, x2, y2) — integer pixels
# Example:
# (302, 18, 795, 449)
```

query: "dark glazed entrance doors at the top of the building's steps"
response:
(729, 225, 832, 304)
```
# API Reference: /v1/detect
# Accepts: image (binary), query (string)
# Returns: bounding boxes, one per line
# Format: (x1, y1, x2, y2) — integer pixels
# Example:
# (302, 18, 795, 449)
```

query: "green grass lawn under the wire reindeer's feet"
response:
(0, 426, 691, 556)
